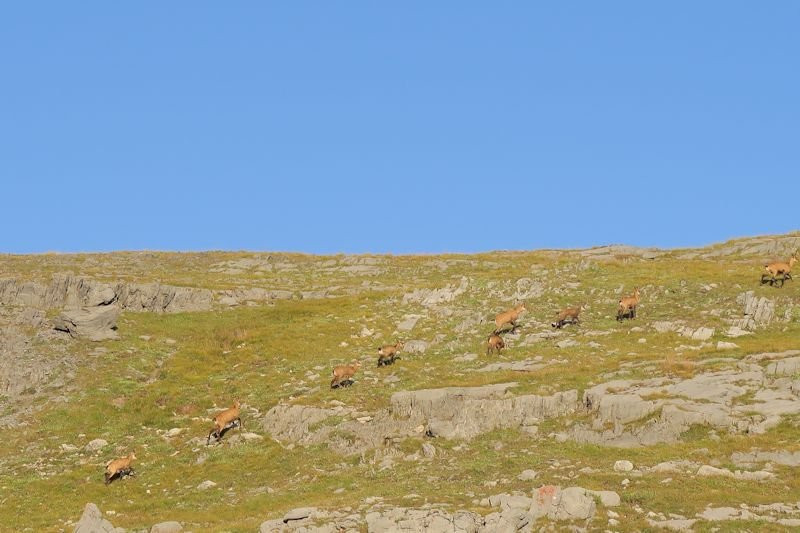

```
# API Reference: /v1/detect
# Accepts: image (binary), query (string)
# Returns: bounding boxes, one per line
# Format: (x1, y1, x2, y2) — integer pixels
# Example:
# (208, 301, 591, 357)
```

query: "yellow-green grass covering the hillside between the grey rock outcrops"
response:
(0, 238, 800, 532)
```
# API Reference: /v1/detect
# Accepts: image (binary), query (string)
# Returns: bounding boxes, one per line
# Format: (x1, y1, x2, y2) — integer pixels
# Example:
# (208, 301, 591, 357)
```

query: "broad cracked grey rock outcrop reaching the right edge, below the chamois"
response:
(567, 351, 800, 448)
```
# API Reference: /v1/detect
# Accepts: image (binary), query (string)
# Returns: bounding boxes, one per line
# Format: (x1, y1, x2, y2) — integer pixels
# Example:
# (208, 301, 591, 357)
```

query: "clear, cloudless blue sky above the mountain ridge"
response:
(0, 0, 800, 253)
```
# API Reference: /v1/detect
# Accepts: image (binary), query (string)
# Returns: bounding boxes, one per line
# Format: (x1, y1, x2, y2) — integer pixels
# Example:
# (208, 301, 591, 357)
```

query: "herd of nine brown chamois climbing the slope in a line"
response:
(104, 251, 798, 484)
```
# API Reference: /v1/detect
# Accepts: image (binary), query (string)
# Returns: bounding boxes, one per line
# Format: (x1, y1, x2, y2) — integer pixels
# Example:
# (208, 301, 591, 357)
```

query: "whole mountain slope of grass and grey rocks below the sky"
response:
(0, 234, 800, 532)
